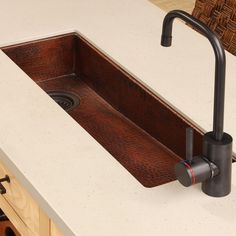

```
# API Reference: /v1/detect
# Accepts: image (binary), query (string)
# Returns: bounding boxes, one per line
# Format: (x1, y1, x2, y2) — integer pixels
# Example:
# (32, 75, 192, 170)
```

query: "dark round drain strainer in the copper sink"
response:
(47, 91, 79, 111)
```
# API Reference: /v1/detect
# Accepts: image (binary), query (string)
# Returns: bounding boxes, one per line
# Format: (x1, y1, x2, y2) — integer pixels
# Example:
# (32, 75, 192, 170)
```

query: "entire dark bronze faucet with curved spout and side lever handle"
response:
(161, 10, 233, 197)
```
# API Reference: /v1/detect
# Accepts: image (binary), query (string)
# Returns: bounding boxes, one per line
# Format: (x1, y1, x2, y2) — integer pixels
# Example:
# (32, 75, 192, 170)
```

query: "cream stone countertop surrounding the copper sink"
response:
(0, 0, 236, 236)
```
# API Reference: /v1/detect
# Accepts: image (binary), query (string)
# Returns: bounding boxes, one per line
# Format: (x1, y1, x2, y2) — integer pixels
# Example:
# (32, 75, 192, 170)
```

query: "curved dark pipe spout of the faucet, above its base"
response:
(161, 10, 226, 141)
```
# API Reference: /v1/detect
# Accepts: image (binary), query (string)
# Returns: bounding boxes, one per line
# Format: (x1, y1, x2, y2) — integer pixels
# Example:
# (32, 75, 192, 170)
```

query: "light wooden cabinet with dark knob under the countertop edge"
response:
(0, 161, 63, 236)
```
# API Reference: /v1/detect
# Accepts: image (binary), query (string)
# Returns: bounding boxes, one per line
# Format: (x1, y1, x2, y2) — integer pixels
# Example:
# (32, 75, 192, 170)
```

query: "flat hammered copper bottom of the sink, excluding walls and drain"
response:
(38, 74, 180, 187)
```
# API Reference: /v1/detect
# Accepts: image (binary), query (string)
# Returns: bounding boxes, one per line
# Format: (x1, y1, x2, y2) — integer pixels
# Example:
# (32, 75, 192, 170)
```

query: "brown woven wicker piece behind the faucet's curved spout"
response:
(192, 0, 236, 55)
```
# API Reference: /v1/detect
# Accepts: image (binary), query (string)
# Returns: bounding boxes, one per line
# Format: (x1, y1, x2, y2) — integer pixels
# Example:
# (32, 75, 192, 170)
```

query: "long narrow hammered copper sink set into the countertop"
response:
(2, 33, 202, 187)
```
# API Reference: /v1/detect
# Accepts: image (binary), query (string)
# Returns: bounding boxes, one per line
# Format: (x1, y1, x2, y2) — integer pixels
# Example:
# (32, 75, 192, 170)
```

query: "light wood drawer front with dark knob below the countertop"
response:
(0, 159, 40, 235)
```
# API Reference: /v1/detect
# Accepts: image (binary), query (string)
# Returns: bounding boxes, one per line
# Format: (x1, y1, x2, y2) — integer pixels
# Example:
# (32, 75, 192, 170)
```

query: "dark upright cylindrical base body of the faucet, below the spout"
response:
(202, 132, 233, 197)
